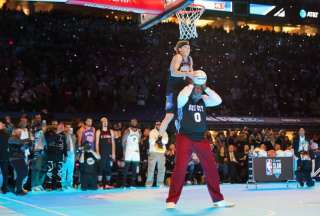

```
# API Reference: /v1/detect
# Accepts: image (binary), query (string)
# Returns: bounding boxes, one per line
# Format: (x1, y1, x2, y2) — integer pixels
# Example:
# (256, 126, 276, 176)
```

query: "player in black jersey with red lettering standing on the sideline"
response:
(96, 117, 116, 189)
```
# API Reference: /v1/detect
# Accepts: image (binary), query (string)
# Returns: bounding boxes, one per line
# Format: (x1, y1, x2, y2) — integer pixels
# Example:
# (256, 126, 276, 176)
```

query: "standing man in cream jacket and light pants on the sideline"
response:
(146, 122, 168, 187)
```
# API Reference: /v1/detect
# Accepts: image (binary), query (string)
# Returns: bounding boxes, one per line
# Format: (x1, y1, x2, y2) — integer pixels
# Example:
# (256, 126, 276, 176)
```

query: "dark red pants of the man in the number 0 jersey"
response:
(167, 134, 223, 203)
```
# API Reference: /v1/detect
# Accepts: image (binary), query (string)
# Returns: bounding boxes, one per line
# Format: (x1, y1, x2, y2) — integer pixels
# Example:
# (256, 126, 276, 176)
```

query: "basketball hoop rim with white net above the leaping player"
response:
(176, 4, 205, 40)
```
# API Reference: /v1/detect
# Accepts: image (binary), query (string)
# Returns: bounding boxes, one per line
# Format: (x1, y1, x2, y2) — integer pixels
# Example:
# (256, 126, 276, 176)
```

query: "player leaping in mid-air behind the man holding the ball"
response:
(159, 41, 193, 135)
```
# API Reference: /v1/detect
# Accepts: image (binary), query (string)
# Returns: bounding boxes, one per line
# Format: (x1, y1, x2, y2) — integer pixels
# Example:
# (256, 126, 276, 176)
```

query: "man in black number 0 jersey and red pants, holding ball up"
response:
(166, 71, 234, 209)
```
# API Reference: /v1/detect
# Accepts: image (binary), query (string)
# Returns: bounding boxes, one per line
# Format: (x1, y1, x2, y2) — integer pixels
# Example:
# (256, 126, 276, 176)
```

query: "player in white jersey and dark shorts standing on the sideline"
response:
(122, 119, 141, 186)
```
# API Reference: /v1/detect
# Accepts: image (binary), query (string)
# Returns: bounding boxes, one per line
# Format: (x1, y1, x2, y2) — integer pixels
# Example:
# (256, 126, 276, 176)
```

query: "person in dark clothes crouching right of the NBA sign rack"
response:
(295, 151, 314, 187)
